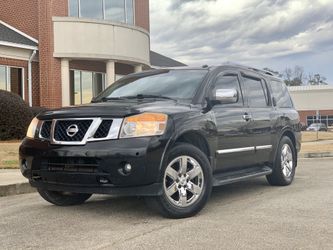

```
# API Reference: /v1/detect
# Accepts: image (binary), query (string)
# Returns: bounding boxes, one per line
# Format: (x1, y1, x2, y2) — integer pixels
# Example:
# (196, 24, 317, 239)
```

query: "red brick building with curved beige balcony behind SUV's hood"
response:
(0, 0, 183, 108)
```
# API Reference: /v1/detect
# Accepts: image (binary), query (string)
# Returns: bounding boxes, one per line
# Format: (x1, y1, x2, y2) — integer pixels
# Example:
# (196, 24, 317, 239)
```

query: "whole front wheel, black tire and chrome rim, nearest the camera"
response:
(146, 143, 212, 219)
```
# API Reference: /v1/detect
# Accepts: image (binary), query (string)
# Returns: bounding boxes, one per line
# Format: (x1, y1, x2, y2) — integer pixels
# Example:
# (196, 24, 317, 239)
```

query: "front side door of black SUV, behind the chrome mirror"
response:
(210, 71, 254, 171)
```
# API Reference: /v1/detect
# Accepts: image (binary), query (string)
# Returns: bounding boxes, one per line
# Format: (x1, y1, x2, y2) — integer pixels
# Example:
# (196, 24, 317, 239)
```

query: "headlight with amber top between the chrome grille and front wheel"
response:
(120, 113, 168, 138)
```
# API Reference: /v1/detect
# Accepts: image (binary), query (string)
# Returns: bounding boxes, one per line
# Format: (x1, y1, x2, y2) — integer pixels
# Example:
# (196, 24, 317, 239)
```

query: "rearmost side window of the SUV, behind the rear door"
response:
(271, 80, 293, 108)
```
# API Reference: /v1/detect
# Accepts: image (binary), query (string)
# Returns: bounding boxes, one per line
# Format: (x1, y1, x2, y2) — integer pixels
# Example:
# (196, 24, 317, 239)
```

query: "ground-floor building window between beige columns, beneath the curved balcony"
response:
(70, 70, 105, 105)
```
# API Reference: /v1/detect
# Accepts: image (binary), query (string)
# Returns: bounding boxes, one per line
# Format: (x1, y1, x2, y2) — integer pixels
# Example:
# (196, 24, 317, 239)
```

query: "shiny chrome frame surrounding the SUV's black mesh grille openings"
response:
(38, 117, 123, 145)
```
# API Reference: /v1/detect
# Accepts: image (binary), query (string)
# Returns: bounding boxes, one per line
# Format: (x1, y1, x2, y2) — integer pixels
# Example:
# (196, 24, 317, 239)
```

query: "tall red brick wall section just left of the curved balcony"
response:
(38, 0, 68, 108)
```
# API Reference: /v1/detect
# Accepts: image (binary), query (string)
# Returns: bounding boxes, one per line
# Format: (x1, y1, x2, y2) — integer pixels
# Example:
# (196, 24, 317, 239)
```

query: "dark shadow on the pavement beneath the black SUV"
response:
(41, 178, 271, 220)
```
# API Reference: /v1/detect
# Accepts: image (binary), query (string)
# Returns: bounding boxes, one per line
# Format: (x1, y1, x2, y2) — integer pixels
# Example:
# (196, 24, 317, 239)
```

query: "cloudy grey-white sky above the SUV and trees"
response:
(150, 0, 333, 84)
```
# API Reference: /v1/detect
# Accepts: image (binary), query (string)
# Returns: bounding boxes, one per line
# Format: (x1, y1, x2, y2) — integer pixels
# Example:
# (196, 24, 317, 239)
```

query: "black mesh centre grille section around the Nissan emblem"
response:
(53, 120, 93, 142)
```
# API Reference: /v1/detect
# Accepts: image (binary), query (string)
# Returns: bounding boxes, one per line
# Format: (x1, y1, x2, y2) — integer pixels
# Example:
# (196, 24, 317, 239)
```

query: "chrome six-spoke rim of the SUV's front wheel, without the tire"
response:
(163, 155, 204, 208)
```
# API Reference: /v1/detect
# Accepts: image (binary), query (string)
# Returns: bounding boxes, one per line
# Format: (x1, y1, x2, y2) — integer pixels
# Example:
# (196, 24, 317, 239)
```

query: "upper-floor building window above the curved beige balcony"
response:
(68, 0, 134, 25)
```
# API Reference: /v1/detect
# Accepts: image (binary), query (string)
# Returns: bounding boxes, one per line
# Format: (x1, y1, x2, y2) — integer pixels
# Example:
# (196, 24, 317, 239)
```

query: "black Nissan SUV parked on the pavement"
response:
(20, 65, 301, 218)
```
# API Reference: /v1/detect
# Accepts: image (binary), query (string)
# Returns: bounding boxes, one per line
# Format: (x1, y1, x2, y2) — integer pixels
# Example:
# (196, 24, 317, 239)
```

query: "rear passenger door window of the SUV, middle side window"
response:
(243, 76, 269, 108)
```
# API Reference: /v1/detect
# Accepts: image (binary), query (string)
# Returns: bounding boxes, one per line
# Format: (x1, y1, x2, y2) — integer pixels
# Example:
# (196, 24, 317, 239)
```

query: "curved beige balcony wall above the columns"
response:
(52, 17, 150, 65)
